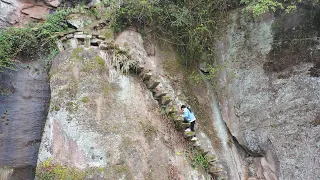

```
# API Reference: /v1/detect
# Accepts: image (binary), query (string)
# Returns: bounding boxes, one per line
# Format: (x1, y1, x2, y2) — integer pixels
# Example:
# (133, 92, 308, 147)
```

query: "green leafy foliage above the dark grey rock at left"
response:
(0, 6, 94, 72)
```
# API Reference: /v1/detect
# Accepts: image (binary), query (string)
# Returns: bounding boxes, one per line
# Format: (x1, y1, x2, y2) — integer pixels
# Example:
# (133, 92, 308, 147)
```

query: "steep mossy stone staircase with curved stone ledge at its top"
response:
(45, 20, 225, 176)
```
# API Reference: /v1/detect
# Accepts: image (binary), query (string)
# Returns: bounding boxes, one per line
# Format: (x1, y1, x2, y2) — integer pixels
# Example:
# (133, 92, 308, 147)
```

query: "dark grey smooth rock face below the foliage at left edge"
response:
(0, 62, 50, 179)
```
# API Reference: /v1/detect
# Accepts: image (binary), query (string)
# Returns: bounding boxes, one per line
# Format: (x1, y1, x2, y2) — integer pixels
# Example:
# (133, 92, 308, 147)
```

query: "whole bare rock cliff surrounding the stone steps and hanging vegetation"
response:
(0, 1, 320, 179)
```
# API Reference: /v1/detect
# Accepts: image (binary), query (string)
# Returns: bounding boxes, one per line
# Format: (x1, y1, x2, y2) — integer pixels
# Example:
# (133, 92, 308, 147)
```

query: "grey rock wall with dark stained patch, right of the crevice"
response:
(217, 9, 320, 179)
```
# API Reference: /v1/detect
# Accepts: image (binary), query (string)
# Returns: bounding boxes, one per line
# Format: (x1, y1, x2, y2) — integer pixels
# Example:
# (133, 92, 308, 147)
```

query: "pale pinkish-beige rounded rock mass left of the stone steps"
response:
(39, 31, 215, 179)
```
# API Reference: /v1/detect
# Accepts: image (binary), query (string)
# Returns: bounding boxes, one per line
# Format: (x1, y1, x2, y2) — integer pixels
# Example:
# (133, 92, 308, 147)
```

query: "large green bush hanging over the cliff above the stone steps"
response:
(113, 0, 233, 64)
